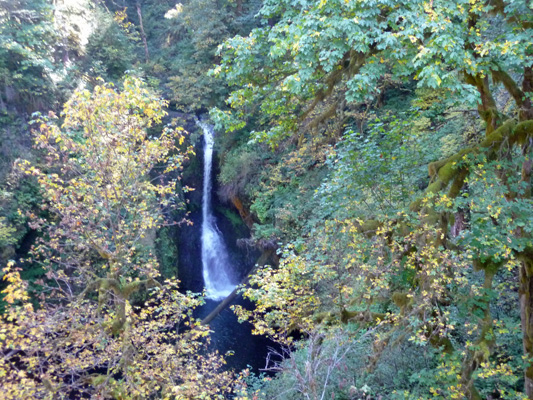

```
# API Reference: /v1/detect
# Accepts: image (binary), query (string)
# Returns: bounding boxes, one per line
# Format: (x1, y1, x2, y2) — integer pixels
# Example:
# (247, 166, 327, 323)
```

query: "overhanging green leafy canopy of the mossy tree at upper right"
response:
(214, 0, 531, 143)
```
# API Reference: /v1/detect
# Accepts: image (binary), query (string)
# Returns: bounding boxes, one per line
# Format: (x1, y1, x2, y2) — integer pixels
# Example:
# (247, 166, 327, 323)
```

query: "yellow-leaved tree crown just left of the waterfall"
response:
(19, 78, 189, 304)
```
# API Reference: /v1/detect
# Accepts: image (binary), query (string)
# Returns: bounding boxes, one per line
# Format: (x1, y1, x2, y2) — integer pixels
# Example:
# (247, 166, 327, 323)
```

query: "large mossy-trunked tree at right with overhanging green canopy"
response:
(212, 0, 533, 399)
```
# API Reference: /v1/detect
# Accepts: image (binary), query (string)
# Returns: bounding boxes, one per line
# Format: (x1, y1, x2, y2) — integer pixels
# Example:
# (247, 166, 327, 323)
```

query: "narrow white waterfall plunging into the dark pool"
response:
(198, 121, 235, 300)
